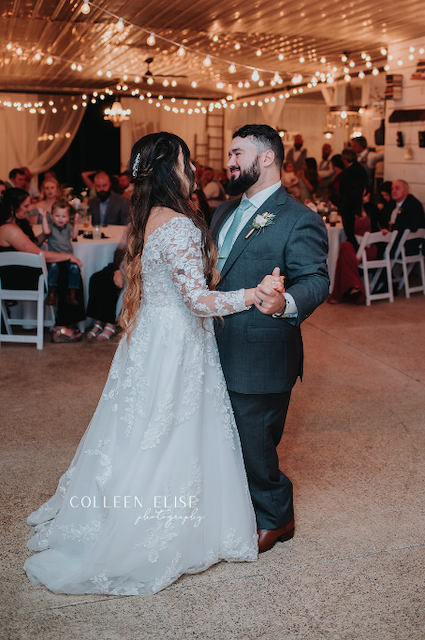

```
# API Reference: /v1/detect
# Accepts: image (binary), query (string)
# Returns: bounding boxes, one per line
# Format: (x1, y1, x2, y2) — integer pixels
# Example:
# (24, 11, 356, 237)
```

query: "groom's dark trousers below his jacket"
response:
(229, 390, 294, 529)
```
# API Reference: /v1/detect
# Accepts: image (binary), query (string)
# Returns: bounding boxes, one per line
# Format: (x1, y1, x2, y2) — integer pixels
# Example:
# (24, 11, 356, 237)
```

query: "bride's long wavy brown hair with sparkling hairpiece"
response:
(120, 131, 220, 338)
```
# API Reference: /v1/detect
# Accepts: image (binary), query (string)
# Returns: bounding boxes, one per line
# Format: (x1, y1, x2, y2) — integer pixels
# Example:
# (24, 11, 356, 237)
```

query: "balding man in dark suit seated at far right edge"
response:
(383, 180, 425, 255)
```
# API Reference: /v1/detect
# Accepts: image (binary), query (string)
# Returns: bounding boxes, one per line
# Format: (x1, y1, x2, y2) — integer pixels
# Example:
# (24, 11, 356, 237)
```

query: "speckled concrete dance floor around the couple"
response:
(0, 295, 425, 640)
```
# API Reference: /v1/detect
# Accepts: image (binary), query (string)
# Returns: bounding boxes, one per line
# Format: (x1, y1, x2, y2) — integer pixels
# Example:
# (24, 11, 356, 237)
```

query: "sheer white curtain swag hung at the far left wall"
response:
(0, 93, 85, 180)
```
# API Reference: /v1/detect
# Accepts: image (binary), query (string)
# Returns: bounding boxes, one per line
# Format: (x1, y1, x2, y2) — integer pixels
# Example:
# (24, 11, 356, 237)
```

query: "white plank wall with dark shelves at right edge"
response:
(385, 37, 425, 204)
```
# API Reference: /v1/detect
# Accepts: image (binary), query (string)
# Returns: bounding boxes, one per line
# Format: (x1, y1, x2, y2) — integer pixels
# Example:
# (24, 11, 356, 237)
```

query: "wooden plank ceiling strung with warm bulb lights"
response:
(0, 0, 425, 99)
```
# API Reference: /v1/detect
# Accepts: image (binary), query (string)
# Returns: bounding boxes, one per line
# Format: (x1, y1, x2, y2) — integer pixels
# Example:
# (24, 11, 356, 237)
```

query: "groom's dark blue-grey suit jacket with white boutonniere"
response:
(211, 187, 329, 394)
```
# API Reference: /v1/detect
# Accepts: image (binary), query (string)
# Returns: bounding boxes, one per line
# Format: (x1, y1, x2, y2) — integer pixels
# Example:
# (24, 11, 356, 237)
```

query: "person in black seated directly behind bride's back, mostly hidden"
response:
(87, 227, 128, 342)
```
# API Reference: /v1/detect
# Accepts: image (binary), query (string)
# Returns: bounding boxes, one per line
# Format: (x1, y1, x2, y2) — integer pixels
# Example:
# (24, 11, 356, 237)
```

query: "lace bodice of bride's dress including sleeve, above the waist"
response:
(142, 216, 249, 317)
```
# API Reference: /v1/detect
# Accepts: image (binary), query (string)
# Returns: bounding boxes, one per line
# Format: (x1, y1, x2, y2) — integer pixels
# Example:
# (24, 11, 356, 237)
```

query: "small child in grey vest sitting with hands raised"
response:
(42, 200, 81, 306)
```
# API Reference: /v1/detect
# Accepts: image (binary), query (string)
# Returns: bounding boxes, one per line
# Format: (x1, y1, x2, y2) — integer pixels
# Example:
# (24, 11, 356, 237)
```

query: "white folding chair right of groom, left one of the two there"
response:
(357, 231, 397, 306)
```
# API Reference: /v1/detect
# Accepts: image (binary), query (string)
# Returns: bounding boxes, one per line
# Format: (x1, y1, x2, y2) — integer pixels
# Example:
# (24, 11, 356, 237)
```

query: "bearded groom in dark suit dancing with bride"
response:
(211, 125, 329, 553)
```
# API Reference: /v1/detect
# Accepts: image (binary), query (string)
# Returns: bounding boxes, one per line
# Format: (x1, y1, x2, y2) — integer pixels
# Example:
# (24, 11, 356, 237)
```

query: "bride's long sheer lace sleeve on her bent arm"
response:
(162, 218, 249, 317)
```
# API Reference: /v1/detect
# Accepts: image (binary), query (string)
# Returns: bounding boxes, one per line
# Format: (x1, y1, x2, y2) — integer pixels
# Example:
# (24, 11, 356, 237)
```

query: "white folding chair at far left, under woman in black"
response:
(0, 251, 55, 349)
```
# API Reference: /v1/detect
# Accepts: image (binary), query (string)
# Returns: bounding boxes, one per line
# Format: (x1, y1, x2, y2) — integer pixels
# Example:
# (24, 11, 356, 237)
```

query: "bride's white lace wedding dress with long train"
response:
(25, 216, 258, 595)
